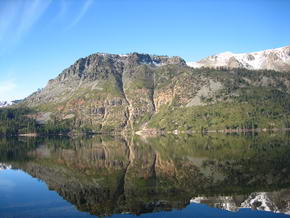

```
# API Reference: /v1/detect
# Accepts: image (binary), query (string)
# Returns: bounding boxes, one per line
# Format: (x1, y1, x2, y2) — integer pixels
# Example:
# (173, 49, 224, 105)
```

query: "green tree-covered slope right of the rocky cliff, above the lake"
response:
(148, 68, 290, 131)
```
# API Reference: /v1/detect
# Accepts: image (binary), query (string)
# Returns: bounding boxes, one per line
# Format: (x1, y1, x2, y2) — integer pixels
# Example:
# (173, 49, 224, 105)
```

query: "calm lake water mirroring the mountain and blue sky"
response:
(0, 133, 290, 218)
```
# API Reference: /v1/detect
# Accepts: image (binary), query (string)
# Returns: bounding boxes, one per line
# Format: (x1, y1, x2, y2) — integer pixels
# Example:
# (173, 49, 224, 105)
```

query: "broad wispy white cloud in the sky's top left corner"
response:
(0, 0, 51, 44)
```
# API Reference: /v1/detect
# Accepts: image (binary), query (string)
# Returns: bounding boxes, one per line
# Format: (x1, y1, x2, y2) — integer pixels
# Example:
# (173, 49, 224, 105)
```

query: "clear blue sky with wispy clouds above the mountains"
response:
(0, 0, 290, 101)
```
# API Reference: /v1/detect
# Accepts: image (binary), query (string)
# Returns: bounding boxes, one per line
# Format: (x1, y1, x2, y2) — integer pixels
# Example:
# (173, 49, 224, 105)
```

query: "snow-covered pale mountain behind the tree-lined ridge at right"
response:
(187, 46, 290, 71)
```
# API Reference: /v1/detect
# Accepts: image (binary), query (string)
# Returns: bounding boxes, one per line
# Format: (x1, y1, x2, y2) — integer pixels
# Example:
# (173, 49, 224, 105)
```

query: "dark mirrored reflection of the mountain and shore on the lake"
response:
(0, 134, 290, 216)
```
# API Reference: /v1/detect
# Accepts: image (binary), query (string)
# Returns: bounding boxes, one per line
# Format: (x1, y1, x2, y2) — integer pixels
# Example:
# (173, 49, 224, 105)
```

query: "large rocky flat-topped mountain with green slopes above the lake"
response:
(19, 53, 290, 131)
